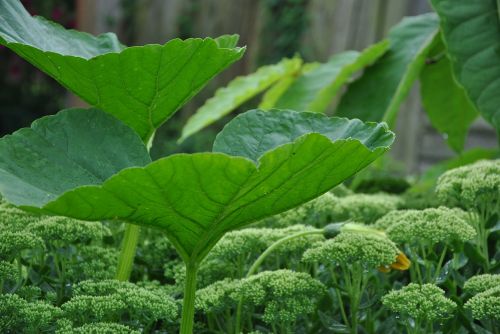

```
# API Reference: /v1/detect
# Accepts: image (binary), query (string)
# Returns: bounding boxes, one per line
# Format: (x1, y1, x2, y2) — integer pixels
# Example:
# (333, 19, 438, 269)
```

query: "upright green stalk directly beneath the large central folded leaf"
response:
(180, 262, 198, 334)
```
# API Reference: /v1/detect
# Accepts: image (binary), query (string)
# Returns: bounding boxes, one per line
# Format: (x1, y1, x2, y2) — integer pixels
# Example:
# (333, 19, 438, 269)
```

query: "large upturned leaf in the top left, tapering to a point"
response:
(0, 0, 244, 141)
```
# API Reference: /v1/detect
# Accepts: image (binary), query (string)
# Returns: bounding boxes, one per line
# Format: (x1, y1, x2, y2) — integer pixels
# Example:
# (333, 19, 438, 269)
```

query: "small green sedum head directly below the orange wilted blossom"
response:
(382, 283, 457, 321)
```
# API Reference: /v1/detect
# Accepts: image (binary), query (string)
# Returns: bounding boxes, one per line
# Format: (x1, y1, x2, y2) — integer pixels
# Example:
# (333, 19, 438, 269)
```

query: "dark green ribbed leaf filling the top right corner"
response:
(431, 0, 500, 133)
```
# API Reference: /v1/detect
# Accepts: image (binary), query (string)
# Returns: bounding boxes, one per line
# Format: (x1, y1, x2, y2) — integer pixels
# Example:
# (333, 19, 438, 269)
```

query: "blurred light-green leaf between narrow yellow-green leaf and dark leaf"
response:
(274, 40, 389, 112)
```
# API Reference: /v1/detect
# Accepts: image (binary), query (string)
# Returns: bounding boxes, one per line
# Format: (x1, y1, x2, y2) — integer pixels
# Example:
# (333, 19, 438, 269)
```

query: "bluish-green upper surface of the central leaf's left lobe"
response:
(0, 109, 151, 207)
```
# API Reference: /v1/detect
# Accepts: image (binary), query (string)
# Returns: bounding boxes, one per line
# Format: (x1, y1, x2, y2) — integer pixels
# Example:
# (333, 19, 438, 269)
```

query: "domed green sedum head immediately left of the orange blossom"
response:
(303, 232, 400, 268)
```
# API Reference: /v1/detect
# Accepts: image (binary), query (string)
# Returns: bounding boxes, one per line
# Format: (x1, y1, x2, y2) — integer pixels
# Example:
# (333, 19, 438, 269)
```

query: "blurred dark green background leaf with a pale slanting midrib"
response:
(336, 13, 439, 125)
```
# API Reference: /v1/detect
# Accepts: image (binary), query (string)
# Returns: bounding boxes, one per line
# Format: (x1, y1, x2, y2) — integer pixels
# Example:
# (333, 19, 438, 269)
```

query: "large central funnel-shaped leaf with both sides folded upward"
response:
(0, 110, 394, 262)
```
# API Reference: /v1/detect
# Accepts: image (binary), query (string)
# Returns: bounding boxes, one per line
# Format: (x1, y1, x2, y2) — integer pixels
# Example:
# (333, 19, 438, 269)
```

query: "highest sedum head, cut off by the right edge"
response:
(436, 160, 500, 212)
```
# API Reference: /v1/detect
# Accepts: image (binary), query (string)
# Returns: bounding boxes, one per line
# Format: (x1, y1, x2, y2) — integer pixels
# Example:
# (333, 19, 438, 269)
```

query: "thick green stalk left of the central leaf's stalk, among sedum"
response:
(115, 224, 141, 281)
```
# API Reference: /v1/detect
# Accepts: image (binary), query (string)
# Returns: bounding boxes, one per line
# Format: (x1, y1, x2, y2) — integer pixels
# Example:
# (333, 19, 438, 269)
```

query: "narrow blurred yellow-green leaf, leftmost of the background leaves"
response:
(179, 58, 302, 141)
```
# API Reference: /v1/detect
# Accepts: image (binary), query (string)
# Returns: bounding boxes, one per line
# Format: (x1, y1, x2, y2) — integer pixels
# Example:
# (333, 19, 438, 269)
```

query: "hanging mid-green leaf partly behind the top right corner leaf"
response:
(420, 35, 478, 152)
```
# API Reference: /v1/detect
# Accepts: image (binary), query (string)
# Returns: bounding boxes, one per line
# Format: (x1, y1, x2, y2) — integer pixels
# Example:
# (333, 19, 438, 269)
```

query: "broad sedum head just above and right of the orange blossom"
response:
(375, 207, 476, 244)
